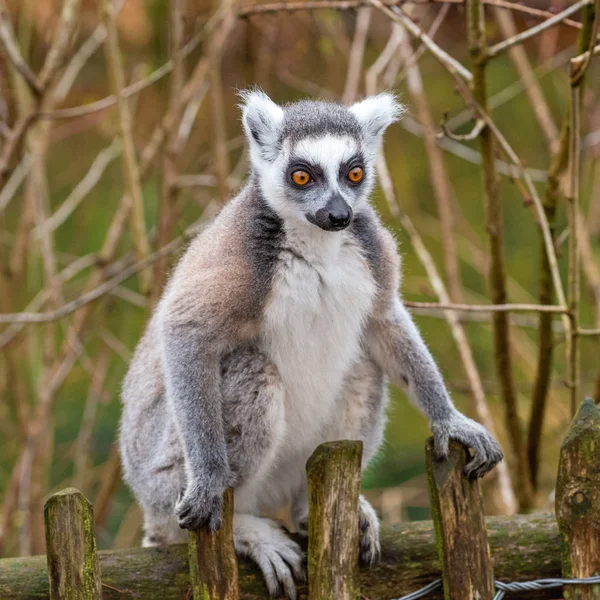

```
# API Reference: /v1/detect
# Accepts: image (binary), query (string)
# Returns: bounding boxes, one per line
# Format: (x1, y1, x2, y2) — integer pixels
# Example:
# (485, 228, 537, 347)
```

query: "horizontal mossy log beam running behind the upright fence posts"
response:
(0, 513, 561, 600)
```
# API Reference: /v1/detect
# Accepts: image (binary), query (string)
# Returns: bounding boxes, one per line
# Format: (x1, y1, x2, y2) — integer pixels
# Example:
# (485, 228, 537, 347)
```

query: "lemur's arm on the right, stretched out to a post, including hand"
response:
(367, 295, 503, 477)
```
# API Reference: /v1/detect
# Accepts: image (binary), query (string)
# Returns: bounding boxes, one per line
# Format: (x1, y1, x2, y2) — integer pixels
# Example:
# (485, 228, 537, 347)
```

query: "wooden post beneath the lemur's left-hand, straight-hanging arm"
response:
(188, 488, 240, 600)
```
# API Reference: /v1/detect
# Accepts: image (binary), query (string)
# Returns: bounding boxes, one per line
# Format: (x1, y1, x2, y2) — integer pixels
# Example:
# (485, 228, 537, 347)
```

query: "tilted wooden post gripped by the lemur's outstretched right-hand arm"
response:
(425, 438, 494, 600)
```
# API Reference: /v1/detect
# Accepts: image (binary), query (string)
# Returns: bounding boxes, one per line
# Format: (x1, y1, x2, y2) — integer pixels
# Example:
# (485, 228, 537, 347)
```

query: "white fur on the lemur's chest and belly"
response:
(262, 227, 376, 450)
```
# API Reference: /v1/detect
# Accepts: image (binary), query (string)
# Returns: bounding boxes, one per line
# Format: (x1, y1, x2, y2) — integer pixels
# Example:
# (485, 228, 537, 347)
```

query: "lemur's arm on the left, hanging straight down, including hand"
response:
(159, 268, 252, 529)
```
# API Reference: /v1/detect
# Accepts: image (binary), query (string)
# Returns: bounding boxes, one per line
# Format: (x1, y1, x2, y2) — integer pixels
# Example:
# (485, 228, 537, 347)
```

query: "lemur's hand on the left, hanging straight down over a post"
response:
(175, 478, 227, 531)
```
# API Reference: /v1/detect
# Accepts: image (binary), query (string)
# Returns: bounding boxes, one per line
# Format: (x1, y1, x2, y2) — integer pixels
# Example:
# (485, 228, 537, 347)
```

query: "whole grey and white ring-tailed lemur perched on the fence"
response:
(120, 90, 503, 600)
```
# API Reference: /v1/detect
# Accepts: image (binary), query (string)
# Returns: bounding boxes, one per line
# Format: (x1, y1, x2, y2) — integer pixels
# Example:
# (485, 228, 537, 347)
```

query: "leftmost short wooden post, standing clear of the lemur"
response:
(44, 488, 102, 600)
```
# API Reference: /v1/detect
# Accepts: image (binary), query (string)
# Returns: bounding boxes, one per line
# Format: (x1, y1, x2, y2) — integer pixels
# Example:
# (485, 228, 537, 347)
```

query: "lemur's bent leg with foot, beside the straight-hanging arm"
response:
(221, 347, 304, 600)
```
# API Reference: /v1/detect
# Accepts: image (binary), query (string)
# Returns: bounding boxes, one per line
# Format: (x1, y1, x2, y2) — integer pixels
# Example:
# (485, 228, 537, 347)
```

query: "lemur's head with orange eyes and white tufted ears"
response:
(242, 91, 402, 231)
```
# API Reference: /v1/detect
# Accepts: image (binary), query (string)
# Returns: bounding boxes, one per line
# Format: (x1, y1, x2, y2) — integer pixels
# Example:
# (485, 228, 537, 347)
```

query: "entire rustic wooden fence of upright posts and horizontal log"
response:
(0, 400, 600, 600)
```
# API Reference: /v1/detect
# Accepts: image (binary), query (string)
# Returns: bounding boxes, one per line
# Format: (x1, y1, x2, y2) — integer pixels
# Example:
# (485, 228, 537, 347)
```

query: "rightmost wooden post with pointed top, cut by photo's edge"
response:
(556, 398, 600, 600)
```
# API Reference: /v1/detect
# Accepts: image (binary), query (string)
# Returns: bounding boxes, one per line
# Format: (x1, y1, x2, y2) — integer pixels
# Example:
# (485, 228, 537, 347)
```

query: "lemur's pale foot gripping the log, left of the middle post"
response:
(233, 515, 306, 600)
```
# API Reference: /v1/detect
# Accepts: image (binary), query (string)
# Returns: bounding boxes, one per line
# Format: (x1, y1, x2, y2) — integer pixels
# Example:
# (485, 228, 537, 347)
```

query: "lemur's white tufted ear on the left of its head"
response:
(240, 90, 283, 161)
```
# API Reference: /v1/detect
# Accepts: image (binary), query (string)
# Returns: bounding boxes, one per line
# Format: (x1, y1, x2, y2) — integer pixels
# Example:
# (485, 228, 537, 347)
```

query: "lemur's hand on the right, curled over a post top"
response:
(431, 411, 504, 479)
